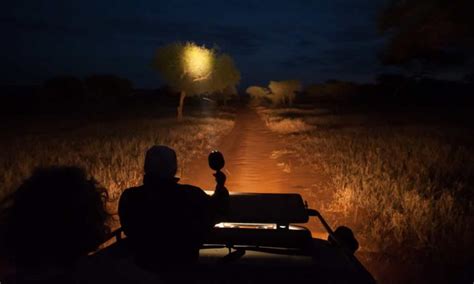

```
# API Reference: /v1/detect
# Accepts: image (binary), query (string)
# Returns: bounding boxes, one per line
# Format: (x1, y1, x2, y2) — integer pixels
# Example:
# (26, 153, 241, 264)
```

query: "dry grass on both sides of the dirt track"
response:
(0, 99, 474, 282)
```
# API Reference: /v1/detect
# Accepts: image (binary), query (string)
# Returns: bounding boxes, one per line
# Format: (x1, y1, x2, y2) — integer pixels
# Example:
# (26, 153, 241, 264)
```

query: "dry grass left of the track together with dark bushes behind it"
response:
(0, 85, 234, 231)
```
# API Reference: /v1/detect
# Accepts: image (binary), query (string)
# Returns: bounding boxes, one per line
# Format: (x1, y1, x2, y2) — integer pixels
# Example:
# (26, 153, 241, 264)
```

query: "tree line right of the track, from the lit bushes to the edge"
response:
(246, 73, 474, 107)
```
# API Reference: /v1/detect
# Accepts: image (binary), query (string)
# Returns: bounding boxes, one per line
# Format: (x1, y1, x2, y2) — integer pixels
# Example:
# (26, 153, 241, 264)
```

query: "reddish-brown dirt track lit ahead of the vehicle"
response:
(181, 108, 334, 237)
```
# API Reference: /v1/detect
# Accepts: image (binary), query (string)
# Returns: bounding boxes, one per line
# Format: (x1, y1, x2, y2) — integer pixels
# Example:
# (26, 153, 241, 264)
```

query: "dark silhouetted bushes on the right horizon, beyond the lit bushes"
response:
(304, 73, 474, 106)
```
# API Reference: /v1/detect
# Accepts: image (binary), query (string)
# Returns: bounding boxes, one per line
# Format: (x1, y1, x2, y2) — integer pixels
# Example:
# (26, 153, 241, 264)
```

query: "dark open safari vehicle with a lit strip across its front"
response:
(99, 154, 375, 283)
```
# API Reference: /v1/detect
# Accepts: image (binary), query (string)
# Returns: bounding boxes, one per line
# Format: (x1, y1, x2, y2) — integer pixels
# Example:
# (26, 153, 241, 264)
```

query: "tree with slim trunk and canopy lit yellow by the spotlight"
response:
(153, 42, 240, 120)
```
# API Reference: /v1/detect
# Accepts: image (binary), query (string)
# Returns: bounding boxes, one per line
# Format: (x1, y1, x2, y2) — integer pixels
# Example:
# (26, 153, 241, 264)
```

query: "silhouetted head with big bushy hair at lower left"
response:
(6, 167, 109, 266)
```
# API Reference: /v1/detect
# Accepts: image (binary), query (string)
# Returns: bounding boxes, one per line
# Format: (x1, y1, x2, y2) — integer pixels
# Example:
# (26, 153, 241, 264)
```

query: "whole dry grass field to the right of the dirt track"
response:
(259, 107, 474, 282)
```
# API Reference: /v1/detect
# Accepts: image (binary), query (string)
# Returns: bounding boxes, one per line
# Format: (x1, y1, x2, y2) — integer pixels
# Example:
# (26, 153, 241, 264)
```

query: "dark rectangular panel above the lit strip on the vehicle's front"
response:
(223, 193, 308, 225)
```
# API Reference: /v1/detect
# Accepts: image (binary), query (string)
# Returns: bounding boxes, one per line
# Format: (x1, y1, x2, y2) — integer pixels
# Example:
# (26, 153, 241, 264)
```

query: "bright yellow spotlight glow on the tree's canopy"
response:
(182, 44, 213, 81)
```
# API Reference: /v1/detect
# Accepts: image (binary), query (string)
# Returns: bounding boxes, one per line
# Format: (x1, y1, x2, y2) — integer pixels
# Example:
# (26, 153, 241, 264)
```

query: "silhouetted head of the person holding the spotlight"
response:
(144, 145, 178, 180)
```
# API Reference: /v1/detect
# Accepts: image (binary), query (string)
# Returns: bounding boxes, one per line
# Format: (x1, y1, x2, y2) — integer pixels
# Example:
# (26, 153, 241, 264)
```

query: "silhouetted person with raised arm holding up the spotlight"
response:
(119, 146, 228, 272)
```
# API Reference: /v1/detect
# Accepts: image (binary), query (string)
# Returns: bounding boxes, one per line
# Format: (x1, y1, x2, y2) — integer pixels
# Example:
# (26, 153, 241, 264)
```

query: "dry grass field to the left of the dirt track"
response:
(0, 108, 233, 222)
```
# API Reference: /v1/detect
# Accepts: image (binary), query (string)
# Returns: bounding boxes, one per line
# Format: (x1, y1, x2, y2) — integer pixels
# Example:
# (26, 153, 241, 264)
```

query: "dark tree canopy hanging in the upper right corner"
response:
(378, 0, 474, 67)
